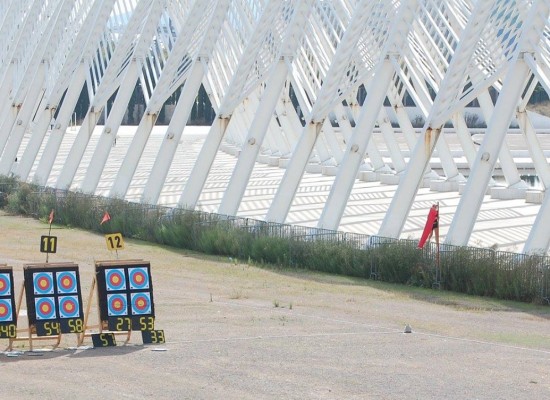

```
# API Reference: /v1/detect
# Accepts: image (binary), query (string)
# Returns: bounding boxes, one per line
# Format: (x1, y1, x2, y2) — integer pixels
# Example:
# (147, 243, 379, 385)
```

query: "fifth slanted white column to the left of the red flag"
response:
(178, 116, 231, 209)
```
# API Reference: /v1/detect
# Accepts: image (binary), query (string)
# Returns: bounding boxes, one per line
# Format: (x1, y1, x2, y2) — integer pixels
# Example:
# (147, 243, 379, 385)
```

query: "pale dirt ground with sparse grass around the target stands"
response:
(0, 214, 550, 399)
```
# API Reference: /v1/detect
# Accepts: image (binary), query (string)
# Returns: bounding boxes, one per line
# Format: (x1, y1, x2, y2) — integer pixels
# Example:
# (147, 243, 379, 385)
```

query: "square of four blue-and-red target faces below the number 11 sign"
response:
(24, 265, 83, 329)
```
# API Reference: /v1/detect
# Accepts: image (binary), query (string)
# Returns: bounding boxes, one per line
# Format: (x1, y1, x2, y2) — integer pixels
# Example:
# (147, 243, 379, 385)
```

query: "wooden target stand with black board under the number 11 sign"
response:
(7, 263, 84, 351)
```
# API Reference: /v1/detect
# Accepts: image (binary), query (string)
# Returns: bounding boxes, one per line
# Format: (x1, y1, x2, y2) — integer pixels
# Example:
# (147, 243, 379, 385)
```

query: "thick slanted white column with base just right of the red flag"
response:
(445, 60, 540, 246)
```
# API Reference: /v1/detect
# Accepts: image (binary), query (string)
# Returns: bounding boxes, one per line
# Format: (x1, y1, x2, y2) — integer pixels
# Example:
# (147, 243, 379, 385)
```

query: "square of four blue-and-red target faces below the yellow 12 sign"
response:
(96, 263, 155, 320)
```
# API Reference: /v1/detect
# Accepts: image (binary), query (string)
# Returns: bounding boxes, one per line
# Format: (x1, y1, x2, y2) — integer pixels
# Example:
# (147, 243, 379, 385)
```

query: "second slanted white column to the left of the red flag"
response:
(317, 59, 395, 230)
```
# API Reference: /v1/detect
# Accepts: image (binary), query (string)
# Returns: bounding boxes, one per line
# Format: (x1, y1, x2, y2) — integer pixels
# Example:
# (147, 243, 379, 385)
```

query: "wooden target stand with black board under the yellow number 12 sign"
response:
(78, 259, 157, 347)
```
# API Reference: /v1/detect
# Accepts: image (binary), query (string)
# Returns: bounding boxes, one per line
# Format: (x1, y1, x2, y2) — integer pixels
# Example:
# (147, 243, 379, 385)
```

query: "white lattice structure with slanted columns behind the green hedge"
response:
(0, 0, 550, 252)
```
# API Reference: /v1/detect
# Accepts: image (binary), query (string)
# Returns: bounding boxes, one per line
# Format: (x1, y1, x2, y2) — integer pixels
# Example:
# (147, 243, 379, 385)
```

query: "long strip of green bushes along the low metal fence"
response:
(0, 177, 550, 304)
